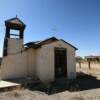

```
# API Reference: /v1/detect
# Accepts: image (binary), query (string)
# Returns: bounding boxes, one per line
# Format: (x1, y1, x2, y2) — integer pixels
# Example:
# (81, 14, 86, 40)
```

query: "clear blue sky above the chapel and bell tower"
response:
(0, 0, 100, 56)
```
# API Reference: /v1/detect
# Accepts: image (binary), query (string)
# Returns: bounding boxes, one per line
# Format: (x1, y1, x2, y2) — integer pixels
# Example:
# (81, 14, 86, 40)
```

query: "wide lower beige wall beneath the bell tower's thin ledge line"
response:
(1, 54, 27, 79)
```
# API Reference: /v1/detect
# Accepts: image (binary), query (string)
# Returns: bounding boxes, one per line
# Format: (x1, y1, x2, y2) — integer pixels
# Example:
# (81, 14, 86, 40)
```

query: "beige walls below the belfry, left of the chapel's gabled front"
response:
(0, 39, 35, 79)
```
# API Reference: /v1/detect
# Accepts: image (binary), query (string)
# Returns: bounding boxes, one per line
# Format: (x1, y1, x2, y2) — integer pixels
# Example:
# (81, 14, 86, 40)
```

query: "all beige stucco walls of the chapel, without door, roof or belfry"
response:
(0, 39, 76, 81)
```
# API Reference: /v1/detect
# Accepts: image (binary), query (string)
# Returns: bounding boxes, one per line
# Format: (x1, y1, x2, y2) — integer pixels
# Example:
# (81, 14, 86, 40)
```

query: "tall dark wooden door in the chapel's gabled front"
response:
(55, 48, 67, 78)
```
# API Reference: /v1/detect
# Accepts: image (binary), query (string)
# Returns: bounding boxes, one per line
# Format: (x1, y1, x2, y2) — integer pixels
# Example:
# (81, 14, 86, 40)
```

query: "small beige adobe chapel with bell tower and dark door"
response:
(0, 17, 77, 82)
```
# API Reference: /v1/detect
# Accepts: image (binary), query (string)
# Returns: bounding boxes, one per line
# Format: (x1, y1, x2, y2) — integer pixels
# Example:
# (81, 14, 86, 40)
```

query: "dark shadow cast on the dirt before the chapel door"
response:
(24, 73, 100, 95)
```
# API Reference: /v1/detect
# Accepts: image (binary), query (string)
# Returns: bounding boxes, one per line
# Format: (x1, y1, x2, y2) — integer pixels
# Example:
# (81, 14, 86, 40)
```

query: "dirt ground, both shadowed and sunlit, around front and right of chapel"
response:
(0, 64, 100, 100)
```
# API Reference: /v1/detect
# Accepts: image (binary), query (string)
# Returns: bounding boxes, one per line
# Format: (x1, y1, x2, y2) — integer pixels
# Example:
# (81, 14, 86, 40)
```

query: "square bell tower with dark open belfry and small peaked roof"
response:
(3, 17, 26, 56)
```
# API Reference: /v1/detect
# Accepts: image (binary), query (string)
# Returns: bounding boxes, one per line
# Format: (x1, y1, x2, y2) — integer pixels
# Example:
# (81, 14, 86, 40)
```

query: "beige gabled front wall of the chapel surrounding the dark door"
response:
(36, 41, 76, 81)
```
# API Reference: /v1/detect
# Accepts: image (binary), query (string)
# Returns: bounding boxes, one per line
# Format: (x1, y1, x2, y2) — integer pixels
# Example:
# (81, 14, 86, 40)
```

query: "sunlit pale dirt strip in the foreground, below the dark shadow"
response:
(0, 89, 100, 100)
